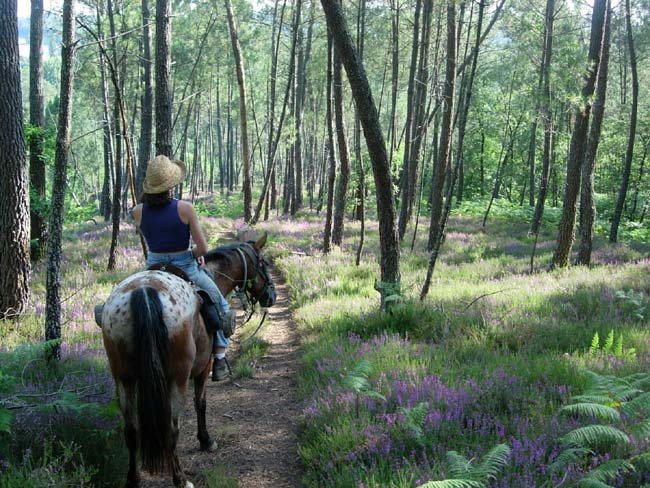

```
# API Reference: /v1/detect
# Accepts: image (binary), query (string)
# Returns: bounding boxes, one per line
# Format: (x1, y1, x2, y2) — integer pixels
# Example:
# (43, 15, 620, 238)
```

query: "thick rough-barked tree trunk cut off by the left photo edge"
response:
(0, 0, 30, 319)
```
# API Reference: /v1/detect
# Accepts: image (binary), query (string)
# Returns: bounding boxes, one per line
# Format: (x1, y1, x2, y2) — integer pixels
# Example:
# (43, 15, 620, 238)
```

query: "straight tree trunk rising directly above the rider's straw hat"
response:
(155, 0, 172, 158)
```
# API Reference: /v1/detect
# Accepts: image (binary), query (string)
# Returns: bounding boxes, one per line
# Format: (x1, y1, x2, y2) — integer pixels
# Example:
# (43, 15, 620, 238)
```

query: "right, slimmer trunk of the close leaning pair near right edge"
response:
(578, 1, 612, 266)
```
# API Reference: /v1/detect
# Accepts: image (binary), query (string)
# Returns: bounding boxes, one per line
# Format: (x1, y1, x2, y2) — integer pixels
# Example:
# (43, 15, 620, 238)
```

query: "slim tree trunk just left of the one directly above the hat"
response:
(135, 0, 153, 193)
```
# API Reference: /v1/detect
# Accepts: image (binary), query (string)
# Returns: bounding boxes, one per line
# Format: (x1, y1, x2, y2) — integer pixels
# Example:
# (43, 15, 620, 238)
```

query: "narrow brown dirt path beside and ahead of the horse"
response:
(141, 268, 301, 488)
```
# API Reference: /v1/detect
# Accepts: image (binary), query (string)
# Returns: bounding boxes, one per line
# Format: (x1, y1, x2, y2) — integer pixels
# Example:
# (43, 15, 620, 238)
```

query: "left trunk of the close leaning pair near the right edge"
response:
(551, 0, 607, 267)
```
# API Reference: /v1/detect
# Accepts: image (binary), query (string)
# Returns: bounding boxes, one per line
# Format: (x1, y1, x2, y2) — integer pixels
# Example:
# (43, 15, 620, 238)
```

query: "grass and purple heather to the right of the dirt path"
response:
(256, 199, 650, 487)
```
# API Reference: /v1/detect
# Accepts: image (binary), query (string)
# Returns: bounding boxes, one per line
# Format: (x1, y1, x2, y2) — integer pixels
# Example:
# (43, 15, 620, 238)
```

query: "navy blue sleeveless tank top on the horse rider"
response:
(140, 200, 190, 253)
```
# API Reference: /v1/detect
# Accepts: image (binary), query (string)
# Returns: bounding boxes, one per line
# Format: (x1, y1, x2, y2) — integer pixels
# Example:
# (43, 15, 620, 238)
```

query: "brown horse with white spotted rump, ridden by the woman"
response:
(97, 235, 275, 488)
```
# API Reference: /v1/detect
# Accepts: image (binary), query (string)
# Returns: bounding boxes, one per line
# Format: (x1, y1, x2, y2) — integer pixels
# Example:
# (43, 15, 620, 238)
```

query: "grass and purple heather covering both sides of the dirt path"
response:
(0, 198, 650, 488)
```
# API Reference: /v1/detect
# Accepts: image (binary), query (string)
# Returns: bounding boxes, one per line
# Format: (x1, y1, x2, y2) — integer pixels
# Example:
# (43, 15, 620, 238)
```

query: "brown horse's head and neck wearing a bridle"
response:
(205, 234, 277, 307)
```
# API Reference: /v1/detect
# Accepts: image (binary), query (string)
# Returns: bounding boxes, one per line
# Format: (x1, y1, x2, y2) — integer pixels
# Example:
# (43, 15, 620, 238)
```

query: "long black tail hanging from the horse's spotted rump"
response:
(131, 287, 172, 473)
